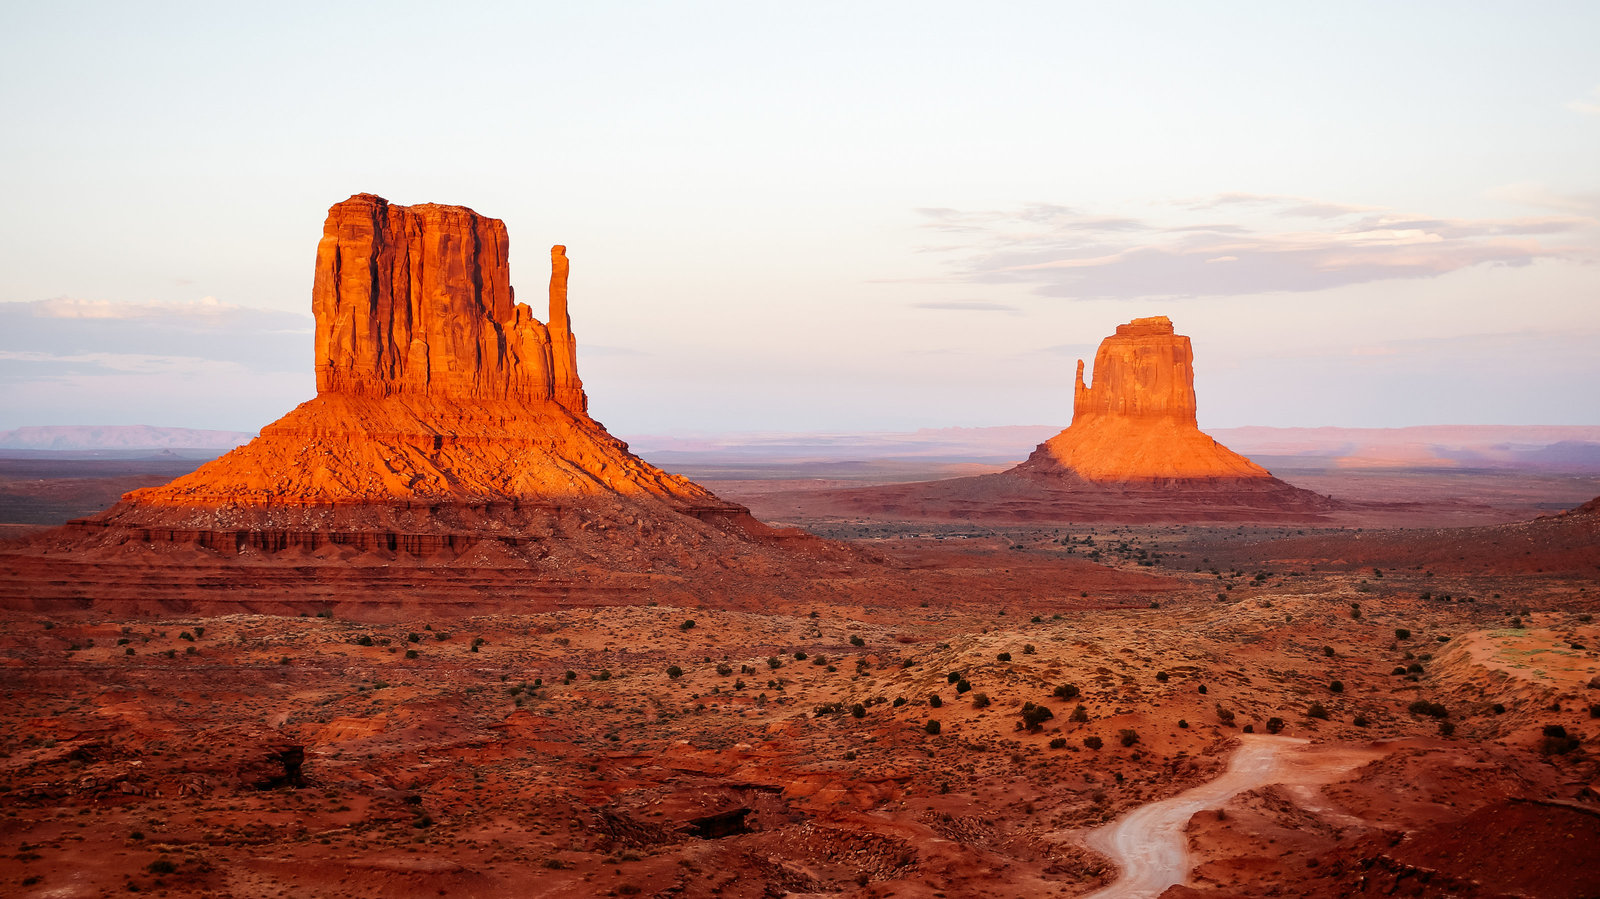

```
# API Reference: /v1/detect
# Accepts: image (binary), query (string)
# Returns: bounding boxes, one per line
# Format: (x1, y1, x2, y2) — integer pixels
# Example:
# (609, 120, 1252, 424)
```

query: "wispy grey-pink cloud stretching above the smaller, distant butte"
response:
(925, 194, 1597, 299)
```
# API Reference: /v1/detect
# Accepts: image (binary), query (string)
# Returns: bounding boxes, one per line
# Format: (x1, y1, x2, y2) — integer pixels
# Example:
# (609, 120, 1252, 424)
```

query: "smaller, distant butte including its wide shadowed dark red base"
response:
(748, 317, 1339, 521)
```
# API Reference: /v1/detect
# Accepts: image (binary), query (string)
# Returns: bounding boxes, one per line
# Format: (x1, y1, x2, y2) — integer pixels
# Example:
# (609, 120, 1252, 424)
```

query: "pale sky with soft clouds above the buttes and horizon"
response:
(0, 0, 1600, 437)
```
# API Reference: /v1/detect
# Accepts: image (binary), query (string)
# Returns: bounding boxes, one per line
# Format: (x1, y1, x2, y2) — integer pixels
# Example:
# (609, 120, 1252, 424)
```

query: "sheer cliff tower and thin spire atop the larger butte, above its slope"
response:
(312, 194, 587, 414)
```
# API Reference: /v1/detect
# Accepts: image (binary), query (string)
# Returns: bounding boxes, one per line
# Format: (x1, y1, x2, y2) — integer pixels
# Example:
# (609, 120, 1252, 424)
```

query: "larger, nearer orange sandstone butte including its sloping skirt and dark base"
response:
(9, 194, 837, 604)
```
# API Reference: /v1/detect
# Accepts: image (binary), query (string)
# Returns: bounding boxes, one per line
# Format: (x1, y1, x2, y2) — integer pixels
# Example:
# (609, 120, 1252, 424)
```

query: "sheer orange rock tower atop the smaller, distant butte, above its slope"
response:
(1072, 315, 1198, 427)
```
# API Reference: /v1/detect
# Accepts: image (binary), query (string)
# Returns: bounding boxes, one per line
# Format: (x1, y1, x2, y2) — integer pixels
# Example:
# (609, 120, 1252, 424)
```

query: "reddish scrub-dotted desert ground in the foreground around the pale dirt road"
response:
(0, 525, 1600, 897)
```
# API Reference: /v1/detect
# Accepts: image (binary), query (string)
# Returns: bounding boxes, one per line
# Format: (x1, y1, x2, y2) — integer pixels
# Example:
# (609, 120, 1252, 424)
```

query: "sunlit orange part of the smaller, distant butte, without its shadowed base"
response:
(1019, 315, 1272, 481)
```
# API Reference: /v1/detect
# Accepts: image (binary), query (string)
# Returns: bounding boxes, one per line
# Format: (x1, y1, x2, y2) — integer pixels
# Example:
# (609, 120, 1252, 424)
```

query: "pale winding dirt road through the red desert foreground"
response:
(1083, 734, 1387, 899)
